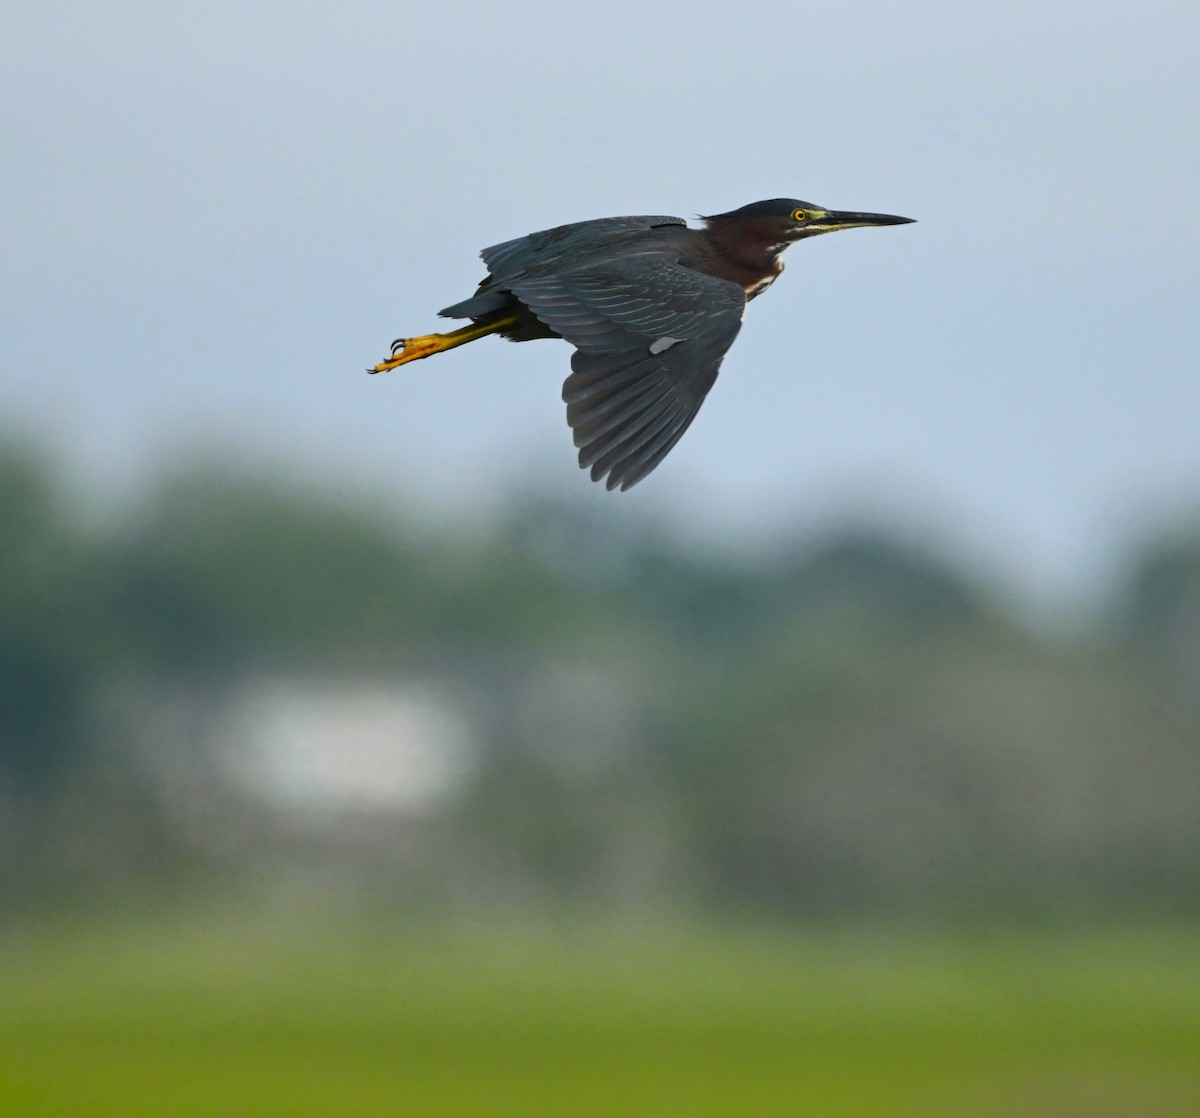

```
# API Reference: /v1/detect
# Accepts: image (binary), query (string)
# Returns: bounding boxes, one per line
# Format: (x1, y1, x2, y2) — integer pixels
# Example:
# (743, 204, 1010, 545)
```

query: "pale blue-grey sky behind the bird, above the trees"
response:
(0, 0, 1200, 594)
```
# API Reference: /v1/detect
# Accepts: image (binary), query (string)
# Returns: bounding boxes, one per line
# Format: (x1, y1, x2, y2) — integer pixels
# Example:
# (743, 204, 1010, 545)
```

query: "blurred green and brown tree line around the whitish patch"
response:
(7, 436, 1200, 919)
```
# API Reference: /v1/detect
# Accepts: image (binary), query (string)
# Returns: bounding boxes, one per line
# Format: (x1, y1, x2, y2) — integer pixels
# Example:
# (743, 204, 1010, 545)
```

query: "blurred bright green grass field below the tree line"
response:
(0, 928, 1200, 1118)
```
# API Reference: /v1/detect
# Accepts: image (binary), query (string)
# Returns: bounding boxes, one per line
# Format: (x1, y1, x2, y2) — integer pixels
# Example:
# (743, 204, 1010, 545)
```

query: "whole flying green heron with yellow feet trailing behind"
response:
(368, 198, 913, 489)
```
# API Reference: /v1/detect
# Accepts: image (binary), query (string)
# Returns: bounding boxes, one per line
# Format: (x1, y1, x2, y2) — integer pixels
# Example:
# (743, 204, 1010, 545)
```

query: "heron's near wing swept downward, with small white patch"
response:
(500, 261, 746, 489)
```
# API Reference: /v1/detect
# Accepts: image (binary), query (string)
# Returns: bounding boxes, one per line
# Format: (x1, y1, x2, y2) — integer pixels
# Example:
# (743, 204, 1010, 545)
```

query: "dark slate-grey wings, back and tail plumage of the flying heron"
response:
(439, 217, 746, 489)
